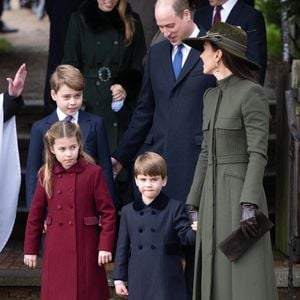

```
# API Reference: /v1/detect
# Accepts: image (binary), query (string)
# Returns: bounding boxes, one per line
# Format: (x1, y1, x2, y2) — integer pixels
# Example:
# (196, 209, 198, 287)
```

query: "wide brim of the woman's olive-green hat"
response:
(182, 35, 261, 70)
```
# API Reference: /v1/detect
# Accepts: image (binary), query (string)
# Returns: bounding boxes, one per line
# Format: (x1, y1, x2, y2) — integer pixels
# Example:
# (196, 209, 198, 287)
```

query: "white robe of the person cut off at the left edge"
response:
(0, 94, 21, 252)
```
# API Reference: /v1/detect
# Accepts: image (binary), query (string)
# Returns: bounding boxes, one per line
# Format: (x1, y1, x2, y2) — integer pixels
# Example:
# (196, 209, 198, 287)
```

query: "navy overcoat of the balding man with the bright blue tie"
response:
(113, 35, 215, 201)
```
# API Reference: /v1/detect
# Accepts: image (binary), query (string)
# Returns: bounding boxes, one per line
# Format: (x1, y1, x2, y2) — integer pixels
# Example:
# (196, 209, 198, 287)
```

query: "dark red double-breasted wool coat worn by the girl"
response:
(24, 160, 116, 300)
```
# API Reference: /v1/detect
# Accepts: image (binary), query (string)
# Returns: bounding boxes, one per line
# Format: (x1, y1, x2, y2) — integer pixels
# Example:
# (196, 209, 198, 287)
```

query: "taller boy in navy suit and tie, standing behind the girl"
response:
(26, 65, 117, 209)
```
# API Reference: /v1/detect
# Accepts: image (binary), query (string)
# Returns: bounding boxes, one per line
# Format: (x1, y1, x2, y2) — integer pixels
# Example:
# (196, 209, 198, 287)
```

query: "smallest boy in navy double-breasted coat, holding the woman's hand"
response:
(113, 152, 197, 300)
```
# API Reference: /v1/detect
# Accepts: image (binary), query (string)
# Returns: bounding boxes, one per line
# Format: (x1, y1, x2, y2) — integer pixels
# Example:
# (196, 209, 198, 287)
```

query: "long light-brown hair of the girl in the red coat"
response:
(39, 121, 95, 198)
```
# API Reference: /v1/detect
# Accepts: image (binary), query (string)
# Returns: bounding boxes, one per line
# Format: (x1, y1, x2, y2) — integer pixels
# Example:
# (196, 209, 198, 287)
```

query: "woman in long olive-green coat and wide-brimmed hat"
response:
(184, 23, 278, 300)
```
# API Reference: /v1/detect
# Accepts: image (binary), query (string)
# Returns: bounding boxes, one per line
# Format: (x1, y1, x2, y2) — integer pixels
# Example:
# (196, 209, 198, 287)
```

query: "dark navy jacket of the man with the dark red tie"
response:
(194, 0, 267, 85)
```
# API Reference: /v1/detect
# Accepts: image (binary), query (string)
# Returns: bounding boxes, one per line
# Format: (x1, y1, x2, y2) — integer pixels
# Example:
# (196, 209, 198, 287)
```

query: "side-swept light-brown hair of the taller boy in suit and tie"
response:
(50, 65, 84, 93)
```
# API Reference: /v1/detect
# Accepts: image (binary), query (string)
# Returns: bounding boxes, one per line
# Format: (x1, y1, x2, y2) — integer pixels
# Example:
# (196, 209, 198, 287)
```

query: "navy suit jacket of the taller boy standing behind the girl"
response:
(26, 110, 117, 209)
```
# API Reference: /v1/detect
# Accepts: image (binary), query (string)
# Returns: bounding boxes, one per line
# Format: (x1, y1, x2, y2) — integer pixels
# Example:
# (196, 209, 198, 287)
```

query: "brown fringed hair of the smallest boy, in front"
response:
(134, 152, 167, 179)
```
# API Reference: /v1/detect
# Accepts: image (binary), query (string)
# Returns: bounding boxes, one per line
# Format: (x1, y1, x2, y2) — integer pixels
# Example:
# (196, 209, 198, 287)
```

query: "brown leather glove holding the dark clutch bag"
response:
(240, 203, 257, 240)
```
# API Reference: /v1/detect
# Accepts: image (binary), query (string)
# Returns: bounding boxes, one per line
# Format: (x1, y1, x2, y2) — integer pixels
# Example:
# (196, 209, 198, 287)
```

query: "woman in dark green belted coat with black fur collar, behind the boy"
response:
(63, 0, 146, 203)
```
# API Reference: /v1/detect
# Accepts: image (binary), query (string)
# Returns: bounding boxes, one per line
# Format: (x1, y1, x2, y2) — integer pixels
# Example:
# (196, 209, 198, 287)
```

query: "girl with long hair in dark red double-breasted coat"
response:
(24, 121, 115, 300)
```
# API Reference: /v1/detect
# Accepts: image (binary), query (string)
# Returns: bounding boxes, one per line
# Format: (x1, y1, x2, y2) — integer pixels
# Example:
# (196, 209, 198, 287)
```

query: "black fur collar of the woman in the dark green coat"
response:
(79, 0, 132, 32)
